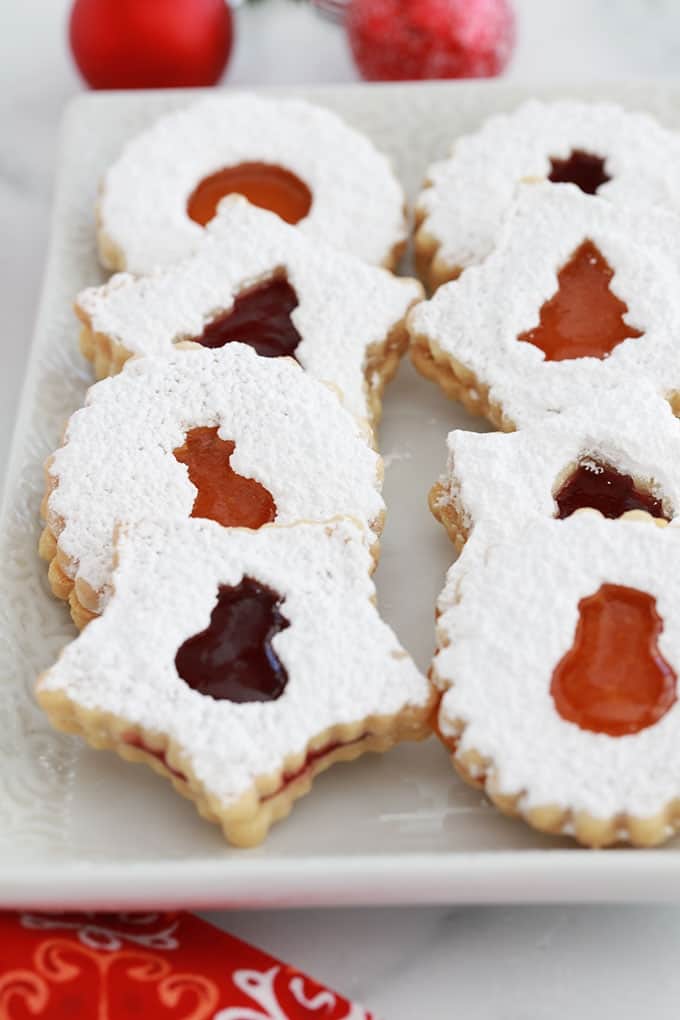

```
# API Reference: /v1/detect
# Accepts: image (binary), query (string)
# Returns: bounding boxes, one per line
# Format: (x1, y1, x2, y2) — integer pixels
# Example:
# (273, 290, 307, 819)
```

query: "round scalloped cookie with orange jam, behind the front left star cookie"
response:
(41, 344, 384, 626)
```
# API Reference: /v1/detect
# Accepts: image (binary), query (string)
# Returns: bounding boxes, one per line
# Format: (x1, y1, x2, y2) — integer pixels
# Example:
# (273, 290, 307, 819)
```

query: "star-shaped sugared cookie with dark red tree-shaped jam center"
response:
(80, 196, 422, 421)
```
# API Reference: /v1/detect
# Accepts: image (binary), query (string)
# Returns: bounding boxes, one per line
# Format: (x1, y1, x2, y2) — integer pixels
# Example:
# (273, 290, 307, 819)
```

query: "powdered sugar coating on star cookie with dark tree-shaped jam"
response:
(77, 196, 422, 418)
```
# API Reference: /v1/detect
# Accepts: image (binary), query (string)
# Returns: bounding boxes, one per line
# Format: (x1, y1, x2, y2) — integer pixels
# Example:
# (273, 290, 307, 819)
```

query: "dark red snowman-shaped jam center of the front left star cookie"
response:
(174, 577, 290, 703)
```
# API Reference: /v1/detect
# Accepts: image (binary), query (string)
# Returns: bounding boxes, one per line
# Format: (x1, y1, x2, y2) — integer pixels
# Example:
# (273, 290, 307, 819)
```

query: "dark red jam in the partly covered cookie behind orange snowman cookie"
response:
(555, 458, 670, 520)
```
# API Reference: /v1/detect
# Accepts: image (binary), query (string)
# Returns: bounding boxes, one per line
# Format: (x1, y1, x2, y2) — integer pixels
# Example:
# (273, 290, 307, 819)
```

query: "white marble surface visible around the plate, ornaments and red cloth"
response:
(0, 0, 680, 1020)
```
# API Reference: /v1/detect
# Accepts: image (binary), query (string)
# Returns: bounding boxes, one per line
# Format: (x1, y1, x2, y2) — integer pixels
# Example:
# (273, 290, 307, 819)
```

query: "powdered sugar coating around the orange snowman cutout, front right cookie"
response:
(434, 514, 680, 819)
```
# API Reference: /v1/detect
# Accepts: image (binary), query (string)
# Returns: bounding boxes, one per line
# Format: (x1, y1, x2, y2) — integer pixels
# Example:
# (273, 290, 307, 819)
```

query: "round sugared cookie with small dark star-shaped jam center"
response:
(416, 100, 680, 289)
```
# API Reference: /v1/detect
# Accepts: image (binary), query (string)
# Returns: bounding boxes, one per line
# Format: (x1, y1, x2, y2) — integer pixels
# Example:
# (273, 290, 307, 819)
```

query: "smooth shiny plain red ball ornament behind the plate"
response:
(69, 0, 232, 89)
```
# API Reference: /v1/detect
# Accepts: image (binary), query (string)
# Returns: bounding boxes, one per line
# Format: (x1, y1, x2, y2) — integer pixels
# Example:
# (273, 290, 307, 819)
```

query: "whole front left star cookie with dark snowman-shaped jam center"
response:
(38, 520, 433, 847)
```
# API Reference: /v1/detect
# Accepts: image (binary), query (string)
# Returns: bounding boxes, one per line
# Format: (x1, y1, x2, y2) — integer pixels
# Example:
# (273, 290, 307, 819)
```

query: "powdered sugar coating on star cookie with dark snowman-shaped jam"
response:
(39, 520, 431, 806)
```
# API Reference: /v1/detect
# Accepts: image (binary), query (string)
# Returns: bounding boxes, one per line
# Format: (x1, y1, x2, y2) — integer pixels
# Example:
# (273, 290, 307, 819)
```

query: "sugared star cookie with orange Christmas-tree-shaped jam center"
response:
(408, 184, 680, 430)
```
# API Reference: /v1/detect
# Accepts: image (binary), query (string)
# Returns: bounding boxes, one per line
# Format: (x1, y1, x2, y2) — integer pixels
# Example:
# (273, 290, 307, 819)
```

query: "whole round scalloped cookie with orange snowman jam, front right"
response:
(432, 512, 680, 847)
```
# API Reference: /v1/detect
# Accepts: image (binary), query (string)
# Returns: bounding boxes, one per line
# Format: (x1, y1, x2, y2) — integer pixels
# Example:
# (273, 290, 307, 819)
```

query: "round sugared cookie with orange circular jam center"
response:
(99, 93, 406, 272)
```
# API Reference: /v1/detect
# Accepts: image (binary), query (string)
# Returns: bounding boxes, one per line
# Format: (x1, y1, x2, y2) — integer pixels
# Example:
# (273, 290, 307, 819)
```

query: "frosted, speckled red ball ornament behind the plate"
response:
(347, 0, 515, 82)
